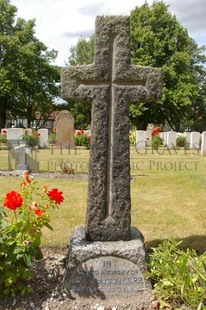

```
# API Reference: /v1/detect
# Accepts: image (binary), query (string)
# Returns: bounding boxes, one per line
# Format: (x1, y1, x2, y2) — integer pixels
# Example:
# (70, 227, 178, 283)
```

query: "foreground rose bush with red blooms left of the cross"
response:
(0, 173, 64, 295)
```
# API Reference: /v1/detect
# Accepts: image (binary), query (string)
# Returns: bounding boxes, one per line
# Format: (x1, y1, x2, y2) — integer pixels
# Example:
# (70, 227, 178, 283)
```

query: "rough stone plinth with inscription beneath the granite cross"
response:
(63, 227, 152, 305)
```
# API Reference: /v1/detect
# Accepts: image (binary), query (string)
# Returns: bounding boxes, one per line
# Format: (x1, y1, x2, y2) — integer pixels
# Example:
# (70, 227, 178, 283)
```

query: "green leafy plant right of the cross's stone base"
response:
(148, 240, 206, 310)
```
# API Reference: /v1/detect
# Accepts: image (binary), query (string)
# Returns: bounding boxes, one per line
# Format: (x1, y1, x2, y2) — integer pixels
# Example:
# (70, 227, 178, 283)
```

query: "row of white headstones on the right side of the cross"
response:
(136, 130, 206, 156)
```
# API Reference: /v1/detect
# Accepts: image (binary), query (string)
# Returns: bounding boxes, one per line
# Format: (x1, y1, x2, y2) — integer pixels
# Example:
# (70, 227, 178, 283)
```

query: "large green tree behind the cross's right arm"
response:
(130, 1, 206, 131)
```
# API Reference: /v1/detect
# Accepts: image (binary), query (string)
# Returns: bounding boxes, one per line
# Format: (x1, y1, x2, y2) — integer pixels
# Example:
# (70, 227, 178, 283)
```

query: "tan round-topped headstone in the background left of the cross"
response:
(56, 110, 74, 147)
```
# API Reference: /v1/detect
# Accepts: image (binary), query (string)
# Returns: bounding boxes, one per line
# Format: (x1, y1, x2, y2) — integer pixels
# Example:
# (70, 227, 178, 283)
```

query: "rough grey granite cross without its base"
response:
(61, 16, 161, 241)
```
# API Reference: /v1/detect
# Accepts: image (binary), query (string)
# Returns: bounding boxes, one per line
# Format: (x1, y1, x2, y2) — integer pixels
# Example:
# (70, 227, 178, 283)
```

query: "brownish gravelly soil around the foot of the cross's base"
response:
(0, 249, 158, 310)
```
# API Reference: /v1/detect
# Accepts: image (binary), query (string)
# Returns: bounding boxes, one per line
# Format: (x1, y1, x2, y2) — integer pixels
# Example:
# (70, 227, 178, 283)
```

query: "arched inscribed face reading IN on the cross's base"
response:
(69, 256, 145, 299)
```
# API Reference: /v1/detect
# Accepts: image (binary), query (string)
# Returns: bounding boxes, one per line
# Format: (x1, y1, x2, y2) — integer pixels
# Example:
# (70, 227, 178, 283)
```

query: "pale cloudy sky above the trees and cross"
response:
(10, 0, 206, 66)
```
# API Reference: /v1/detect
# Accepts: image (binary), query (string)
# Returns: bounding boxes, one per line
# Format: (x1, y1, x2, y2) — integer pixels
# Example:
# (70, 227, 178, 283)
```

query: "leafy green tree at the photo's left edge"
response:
(0, 0, 60, 128)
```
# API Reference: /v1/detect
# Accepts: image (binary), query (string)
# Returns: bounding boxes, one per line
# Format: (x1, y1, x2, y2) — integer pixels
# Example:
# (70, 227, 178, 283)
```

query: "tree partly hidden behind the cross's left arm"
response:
(68, 36, 94, 129)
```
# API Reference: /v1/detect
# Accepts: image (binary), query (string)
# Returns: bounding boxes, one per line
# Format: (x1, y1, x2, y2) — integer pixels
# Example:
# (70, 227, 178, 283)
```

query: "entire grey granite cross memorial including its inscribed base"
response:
(61, 16, 161, 303)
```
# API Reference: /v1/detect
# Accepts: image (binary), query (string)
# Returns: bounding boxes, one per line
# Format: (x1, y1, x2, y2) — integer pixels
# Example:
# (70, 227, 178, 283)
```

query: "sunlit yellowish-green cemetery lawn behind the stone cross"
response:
(0, 149, 206, 253)
